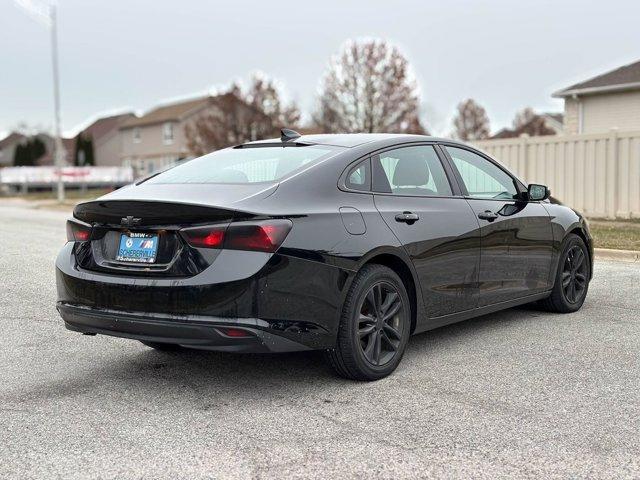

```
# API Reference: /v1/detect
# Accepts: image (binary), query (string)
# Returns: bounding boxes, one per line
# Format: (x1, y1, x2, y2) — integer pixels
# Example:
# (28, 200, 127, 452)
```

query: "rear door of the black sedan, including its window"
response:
(372, 145, 480, 318)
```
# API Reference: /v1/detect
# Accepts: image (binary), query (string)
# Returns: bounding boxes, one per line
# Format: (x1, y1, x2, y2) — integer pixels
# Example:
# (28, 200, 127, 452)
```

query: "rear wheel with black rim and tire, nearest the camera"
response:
(326, 264, 411, 381)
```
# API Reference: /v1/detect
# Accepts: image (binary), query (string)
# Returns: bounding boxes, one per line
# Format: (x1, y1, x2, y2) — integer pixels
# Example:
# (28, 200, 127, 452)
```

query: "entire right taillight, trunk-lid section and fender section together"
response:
(180, 220, 292, 252)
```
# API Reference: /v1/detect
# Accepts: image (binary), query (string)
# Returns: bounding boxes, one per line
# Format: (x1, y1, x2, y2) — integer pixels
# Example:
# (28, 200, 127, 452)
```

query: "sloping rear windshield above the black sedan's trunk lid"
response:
(145, 145, 338, 183)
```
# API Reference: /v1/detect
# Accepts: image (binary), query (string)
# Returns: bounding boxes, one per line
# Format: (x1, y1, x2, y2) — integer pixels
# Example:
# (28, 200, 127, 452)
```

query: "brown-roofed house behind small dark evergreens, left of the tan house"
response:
(74, 113, 136, 167)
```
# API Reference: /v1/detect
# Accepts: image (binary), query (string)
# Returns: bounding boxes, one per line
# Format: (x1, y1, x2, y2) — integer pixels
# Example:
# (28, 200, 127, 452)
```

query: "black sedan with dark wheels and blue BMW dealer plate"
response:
(56, 130, 593, 380)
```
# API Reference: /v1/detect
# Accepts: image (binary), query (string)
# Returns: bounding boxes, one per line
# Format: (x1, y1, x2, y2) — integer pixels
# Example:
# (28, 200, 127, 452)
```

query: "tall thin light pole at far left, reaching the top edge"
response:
(14, 0, 65, 202)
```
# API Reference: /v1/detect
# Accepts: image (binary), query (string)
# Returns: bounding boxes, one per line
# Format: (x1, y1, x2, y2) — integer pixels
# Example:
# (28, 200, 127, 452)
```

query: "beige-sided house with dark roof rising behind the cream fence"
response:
(553, 61, 640, 134)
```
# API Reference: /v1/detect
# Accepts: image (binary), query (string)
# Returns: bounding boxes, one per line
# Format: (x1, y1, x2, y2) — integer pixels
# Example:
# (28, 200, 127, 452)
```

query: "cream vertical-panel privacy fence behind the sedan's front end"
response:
(474, 130, 640, 218)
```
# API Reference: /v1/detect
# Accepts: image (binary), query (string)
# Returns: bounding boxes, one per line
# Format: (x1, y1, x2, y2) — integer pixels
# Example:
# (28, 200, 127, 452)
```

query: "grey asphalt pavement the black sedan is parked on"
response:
(0, 204, 640, 479)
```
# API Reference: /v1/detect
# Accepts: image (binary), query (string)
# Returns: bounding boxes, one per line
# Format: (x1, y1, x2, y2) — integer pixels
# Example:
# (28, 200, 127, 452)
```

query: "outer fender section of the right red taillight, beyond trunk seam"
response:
(224, 220, 291, 252)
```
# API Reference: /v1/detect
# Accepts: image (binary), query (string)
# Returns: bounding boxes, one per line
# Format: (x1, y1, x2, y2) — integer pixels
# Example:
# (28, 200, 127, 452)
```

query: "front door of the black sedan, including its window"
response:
(443, 145, 553, 306)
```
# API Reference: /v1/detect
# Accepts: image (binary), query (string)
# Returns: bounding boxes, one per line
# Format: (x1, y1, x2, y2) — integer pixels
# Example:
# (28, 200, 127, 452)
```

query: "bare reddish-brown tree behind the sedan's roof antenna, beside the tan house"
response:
(185, 75, 300, 155)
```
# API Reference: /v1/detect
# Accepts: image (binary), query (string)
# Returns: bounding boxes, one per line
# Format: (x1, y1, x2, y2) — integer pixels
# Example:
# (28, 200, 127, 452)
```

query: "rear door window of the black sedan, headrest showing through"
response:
(374, 145, 452, 196)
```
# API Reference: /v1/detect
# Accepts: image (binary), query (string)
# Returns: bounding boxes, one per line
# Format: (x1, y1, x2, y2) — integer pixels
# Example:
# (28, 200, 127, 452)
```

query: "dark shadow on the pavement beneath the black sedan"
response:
(7, 308, 542, 409)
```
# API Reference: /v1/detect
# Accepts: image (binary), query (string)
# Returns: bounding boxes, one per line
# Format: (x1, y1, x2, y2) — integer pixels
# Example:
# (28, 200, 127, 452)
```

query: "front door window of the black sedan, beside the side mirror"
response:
(445, 147, 518, 200)
